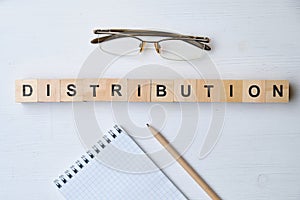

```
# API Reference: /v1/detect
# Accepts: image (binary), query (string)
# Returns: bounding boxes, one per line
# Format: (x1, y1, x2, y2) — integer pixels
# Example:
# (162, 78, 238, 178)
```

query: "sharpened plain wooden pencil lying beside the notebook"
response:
(147, 124, 220, 200)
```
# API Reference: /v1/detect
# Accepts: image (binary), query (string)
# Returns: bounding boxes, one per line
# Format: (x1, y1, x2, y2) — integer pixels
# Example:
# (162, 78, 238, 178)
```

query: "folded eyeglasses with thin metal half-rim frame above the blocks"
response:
(91, 29, 211, 60)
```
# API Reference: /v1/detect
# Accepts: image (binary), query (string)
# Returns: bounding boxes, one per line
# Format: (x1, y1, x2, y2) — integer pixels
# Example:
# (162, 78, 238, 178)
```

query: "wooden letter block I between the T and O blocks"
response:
(221, 80, 243, 102)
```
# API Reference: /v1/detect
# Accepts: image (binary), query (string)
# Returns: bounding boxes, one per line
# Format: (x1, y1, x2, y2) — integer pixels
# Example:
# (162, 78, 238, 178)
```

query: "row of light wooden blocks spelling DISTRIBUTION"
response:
(15, 78, 289, 103)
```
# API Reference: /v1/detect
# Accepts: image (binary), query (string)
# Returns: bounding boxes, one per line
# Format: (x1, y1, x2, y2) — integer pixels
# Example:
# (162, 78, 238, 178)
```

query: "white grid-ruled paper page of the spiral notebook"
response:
(55, 128, 186, 200)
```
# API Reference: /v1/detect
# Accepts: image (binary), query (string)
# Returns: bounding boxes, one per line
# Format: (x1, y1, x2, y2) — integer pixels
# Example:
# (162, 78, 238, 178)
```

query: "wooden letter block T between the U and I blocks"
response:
(197, 79, 225, 102)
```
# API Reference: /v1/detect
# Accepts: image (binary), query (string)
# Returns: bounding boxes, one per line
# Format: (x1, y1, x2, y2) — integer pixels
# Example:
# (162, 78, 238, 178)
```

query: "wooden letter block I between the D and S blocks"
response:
(37, 79, 60, 102)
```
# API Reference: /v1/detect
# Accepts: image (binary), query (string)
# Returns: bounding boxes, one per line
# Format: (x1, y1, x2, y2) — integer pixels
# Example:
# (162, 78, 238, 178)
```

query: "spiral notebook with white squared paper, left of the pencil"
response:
(54, 125, 187, 200)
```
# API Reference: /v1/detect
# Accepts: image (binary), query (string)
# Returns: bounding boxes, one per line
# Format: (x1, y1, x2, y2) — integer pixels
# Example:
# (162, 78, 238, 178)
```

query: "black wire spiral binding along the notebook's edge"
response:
(53, 125, 123, 189)
